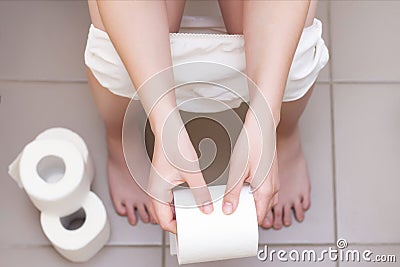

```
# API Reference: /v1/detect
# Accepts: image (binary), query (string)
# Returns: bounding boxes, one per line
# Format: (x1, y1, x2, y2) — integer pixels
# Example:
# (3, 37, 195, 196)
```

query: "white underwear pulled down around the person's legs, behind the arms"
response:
(85, 19, 329, 113)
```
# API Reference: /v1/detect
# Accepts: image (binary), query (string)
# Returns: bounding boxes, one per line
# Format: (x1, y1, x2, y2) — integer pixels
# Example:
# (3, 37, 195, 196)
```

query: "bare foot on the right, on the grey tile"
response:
(262, 127, 311, 230)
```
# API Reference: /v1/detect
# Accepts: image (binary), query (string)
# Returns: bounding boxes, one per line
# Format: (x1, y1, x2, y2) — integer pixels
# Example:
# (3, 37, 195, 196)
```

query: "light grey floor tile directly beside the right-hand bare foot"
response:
(260, 84, 334, 244)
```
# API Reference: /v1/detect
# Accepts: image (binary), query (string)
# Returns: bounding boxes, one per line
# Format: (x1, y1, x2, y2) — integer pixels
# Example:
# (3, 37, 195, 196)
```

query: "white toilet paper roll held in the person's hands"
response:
(170, 185, 258, 264)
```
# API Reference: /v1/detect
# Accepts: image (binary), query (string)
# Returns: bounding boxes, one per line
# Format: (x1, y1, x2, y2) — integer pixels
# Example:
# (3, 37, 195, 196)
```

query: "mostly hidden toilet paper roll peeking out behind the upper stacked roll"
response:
(35, 127, 94, 184)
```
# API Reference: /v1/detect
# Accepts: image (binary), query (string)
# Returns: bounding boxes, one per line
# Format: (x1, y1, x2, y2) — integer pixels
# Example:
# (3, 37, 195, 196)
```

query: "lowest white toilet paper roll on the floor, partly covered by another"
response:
(40, 192, 110, 262)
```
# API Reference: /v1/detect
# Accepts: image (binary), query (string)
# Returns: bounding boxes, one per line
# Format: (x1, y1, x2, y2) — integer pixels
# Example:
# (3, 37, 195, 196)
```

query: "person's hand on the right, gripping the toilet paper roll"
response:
(222, 110, 279, 224)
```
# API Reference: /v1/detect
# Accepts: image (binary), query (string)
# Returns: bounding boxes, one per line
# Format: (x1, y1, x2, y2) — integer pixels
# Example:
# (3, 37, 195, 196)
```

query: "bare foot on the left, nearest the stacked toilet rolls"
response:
(107, 136, 156, 225)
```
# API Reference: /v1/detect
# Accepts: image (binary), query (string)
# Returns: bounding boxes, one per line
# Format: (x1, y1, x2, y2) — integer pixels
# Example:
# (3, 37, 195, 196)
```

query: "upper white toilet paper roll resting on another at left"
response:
(18, 140, 92, 216)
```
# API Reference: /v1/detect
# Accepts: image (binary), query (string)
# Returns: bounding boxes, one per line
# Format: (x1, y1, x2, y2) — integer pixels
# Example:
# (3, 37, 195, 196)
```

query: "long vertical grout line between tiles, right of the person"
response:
(328, 1, 340, 267)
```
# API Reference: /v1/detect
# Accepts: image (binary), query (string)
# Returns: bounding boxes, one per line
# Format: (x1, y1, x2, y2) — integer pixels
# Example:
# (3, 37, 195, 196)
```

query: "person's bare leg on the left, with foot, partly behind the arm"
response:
(87, 1, 185, 225)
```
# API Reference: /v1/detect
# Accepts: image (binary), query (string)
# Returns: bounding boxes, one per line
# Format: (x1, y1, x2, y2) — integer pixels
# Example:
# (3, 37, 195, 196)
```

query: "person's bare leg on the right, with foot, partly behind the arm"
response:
(219, 0, 317, 229)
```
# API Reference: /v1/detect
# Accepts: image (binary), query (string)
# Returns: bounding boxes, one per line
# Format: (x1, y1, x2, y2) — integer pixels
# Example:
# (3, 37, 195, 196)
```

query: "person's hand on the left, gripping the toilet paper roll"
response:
(148, 122, 213, 233)
